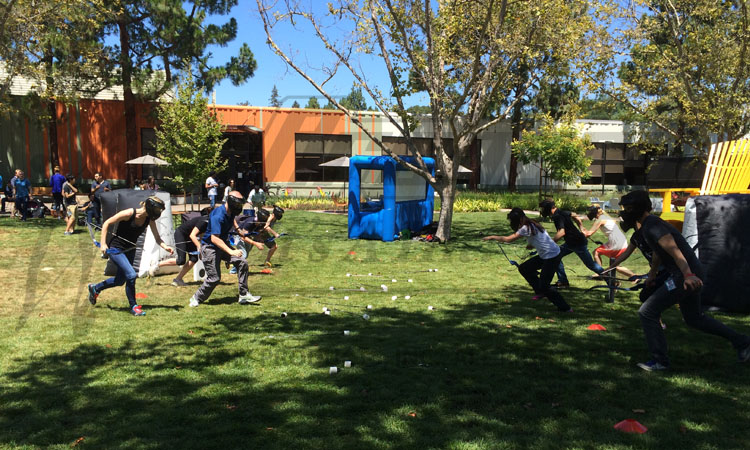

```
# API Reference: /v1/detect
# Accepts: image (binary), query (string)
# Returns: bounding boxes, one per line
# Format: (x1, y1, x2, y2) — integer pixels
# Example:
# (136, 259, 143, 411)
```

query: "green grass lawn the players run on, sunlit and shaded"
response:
(0, 211, 750, 449)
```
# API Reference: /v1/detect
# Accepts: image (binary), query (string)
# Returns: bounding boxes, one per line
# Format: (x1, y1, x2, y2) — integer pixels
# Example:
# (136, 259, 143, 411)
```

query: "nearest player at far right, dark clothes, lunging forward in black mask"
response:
(620, 191, 750, 371)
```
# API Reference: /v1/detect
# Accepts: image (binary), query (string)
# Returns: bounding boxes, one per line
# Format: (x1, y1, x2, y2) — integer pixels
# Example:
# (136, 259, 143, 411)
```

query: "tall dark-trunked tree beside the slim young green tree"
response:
(102, 0, 257, 183)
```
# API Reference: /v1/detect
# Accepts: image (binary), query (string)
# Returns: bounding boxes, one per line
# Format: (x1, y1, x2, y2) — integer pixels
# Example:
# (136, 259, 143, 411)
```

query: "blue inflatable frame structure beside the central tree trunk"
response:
(349, 156, 435, 242)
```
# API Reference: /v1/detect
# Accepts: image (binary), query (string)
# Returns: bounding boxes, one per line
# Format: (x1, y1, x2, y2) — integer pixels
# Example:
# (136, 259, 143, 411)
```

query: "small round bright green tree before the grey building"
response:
(511, 116, 594, 194)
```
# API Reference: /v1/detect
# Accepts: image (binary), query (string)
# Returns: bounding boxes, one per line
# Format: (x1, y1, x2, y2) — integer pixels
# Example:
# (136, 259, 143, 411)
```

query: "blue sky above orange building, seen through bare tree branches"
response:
(209, 0, 427, 107)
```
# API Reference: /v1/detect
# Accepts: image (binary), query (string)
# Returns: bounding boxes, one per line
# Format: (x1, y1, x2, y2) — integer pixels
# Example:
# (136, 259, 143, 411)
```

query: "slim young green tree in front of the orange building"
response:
(156, 72, 227, 209)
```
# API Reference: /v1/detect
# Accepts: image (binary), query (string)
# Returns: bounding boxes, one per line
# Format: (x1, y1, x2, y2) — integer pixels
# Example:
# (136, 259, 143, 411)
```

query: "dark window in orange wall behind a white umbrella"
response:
(294, 133, 352, 181)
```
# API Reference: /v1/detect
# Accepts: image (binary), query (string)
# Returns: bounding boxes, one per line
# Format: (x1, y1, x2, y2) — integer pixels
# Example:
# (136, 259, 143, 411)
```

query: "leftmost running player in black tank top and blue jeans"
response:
(88, 196, 174, 316)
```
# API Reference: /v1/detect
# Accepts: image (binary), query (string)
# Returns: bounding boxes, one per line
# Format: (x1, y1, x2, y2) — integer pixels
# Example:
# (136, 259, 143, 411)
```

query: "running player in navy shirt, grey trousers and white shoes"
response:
(189, 191, 261, 307)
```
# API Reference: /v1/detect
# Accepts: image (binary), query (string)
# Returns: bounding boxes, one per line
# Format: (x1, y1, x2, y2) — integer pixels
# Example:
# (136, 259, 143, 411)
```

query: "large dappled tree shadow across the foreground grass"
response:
(0, 298, 748, 449)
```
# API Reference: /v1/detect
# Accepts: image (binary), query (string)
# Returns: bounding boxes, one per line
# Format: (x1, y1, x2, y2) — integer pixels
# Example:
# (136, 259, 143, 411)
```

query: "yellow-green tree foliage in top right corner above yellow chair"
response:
(588, 0, 750, 156)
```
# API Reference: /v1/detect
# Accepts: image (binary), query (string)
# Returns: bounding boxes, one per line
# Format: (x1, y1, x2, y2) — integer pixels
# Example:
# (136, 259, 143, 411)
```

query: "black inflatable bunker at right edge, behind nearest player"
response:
(695, 194, 750, 313)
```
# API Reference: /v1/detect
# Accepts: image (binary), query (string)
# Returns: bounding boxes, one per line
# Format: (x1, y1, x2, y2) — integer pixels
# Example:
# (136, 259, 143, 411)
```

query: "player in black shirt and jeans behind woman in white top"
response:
(539, 199, 604, 288)
